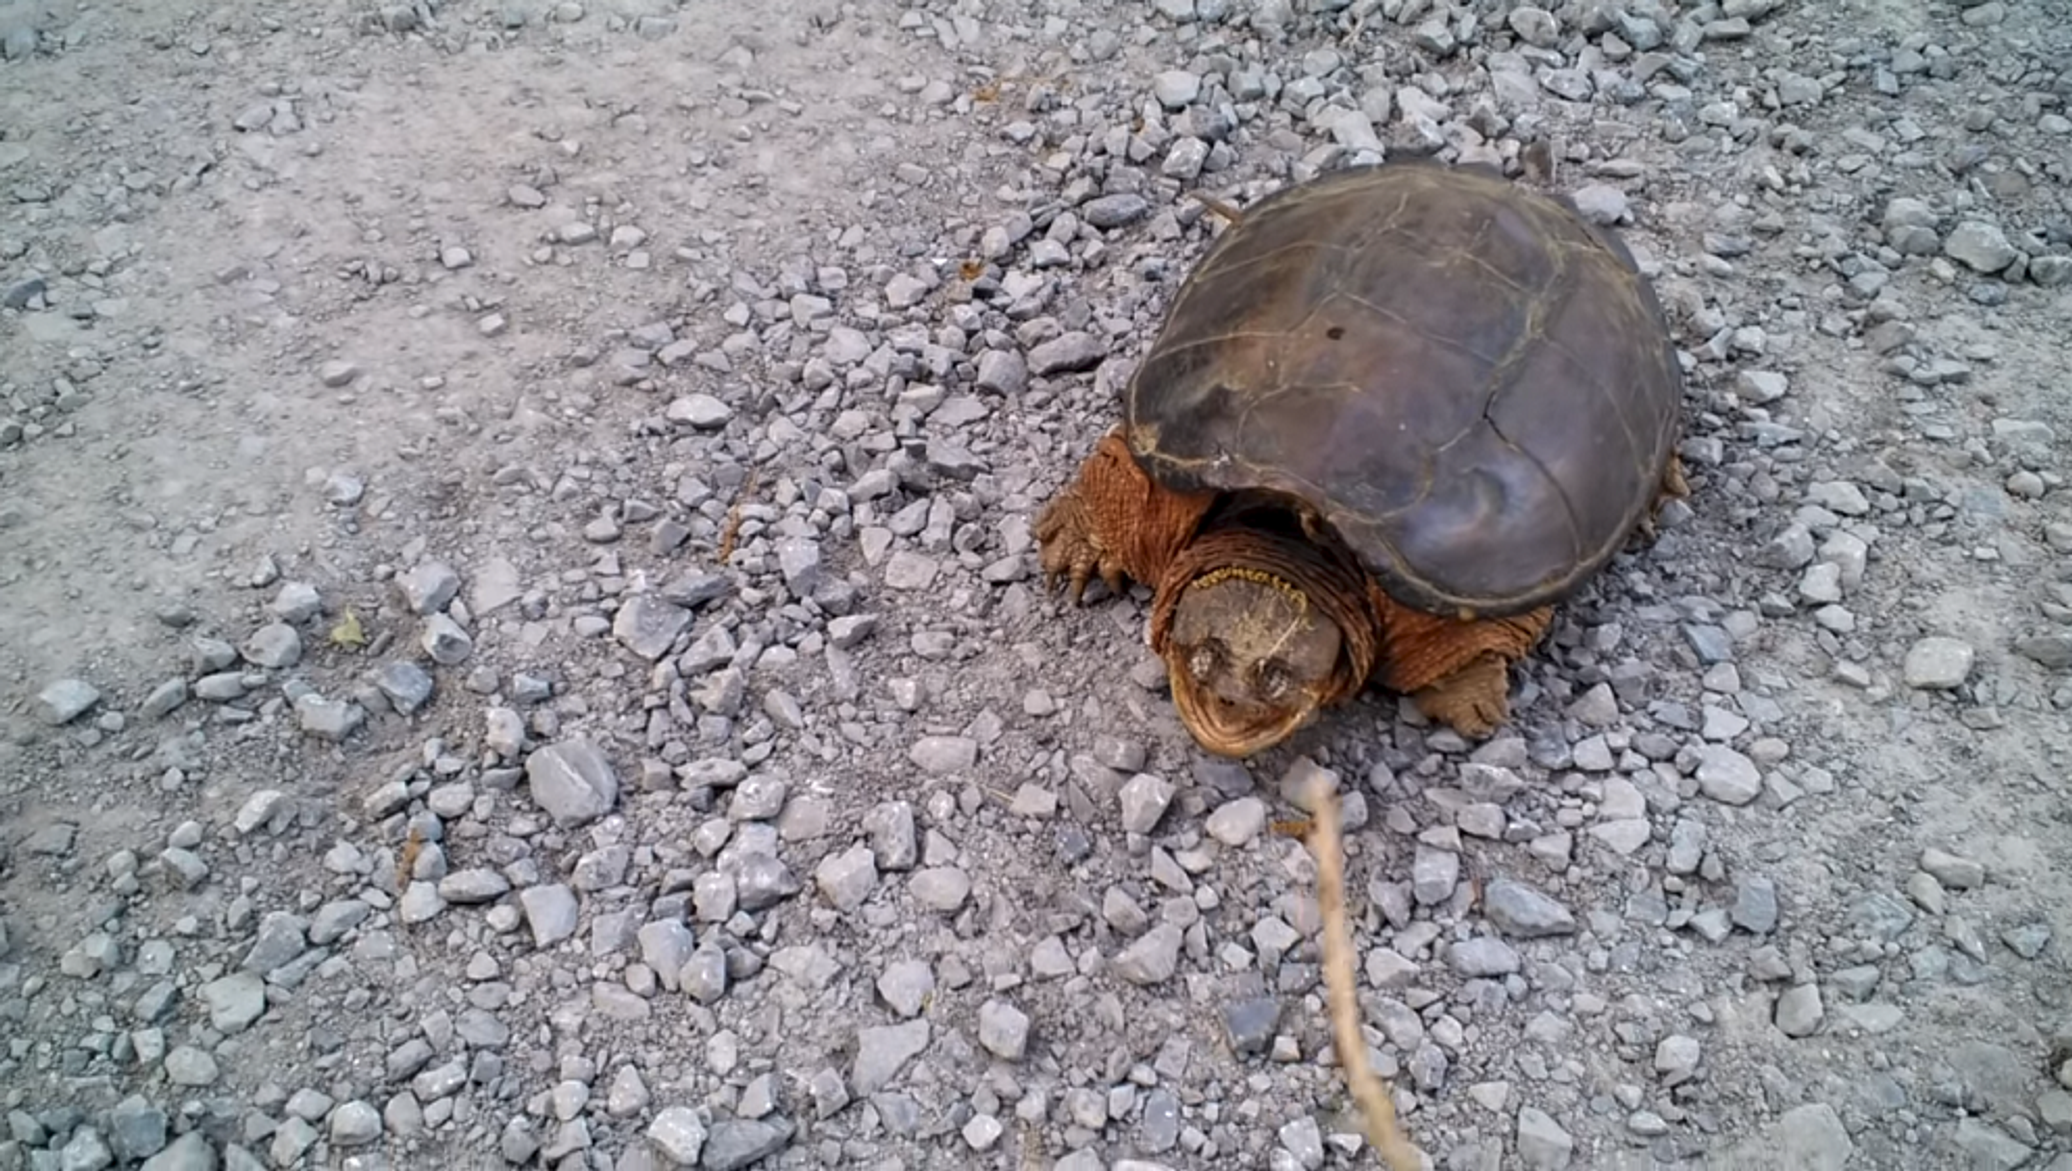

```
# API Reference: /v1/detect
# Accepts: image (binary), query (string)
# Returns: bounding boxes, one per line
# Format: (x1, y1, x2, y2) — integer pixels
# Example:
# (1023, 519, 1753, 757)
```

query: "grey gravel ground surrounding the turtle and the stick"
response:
(0, 0, 2072, 1171)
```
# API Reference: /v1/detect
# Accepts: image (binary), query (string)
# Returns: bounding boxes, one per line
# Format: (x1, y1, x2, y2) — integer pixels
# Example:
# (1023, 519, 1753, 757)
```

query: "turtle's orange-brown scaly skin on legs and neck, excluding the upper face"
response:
(1036, 431, 1552, 756)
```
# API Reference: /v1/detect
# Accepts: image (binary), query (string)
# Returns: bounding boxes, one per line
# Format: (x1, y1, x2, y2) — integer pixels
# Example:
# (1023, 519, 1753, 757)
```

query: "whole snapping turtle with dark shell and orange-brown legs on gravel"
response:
(1034, 160, 1689, 759)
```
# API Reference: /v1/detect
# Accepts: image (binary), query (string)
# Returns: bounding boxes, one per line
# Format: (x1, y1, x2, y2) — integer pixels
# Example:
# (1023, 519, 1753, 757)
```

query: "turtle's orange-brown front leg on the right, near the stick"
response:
(1374, 589, 1554, 740)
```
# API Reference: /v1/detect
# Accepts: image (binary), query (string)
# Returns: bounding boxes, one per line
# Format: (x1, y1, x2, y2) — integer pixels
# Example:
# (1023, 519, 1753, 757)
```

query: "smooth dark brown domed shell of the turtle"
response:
(1125, 162, 1682, 618)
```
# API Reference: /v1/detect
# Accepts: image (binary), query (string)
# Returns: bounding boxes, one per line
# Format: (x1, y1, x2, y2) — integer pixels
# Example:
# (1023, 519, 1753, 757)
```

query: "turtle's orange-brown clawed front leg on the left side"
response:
(1036, 429, 1214, 603)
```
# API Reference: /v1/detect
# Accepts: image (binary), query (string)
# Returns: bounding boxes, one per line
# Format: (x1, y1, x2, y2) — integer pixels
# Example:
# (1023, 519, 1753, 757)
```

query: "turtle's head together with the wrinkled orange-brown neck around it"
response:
(1152, 510, 1380, 759)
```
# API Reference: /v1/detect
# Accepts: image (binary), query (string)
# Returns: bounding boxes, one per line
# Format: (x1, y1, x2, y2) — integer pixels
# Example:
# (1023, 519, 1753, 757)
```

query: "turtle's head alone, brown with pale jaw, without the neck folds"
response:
(1164, 566, 1345, 756)
